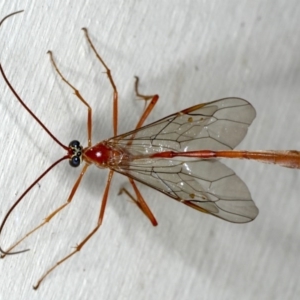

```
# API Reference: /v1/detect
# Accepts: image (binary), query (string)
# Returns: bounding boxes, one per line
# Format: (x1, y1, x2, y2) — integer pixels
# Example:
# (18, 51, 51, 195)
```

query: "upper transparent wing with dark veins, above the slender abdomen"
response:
(109, 98, 256, 154)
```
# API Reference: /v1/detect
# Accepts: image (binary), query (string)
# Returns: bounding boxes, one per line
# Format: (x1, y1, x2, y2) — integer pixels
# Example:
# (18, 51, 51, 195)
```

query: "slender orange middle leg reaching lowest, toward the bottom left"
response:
(33, 170, 114, 290)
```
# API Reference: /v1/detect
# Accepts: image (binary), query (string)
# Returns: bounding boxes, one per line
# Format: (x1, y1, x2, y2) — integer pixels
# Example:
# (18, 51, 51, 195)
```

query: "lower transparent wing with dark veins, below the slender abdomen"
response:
(114, 158, 258, 223)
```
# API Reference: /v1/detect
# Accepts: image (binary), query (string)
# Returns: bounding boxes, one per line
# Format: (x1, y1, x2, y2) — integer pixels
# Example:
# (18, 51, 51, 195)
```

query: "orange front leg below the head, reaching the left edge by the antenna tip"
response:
(0, 164, 89, 258)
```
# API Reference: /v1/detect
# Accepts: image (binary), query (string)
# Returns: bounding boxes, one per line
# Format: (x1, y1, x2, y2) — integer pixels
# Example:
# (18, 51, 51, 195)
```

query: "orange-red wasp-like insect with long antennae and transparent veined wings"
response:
(0, 11, 300, 289)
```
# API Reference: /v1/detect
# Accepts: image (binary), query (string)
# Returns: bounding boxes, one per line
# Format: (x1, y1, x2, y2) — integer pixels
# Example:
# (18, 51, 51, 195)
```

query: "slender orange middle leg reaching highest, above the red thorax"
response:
(82, 28, 118, 136)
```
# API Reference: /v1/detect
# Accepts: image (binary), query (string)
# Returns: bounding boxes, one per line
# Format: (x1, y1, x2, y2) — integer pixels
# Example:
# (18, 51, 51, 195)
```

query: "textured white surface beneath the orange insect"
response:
(0, 0, 300, 299)
